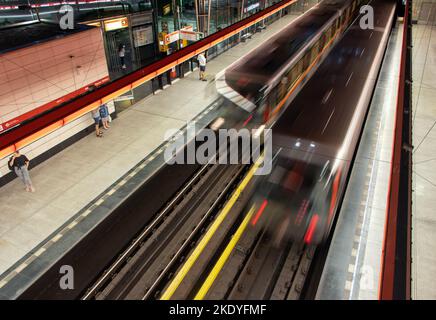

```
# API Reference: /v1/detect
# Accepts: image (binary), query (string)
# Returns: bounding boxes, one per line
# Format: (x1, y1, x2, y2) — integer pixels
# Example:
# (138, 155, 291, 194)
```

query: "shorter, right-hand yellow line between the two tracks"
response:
(194, 206, 254, 300)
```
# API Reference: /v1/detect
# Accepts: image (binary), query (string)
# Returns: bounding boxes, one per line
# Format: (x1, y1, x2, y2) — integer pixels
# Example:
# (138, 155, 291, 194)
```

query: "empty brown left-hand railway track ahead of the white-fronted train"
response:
(82, 134, 260, 299)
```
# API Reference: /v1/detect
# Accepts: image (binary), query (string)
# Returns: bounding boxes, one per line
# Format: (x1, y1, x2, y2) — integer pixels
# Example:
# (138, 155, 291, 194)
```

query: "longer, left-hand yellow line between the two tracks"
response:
(160, 154, 263, 300)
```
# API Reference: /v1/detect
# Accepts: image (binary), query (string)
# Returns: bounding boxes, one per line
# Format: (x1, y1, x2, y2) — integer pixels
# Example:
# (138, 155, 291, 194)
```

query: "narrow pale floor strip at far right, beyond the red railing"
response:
(412, 21, 436, 299)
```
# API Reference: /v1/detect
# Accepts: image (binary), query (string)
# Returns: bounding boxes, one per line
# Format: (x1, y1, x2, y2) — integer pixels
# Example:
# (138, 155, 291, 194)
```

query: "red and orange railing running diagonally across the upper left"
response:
(0, 0, 297, 159)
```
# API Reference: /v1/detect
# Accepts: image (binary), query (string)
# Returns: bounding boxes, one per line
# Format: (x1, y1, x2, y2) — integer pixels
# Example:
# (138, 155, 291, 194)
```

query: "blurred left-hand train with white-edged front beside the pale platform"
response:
(215, 0, 368, 127)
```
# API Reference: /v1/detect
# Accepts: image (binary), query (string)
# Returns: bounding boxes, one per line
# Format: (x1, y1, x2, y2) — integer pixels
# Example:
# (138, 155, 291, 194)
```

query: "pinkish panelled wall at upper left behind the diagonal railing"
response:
(0, 28, 108, 124)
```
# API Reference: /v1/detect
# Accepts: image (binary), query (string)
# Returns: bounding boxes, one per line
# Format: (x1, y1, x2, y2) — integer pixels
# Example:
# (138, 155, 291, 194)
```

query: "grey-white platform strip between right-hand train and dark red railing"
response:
(317, 24, 402, 300)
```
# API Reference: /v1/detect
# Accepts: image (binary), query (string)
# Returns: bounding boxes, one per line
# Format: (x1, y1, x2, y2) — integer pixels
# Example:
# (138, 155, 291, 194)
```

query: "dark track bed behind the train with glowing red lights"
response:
(194, 205, 316, 300)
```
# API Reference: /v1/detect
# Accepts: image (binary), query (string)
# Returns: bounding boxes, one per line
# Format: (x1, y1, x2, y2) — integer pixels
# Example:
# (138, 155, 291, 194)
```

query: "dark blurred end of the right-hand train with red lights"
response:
(250, 135, 348, 246)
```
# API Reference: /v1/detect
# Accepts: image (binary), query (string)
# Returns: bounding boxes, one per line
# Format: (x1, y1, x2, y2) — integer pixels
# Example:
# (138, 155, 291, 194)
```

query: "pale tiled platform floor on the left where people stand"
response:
(0, 15, 304, 274)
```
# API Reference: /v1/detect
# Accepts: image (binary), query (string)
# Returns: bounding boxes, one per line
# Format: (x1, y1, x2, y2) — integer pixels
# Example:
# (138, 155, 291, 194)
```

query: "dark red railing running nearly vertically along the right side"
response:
(379, 0, 412, 300)
